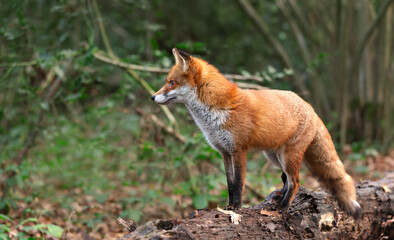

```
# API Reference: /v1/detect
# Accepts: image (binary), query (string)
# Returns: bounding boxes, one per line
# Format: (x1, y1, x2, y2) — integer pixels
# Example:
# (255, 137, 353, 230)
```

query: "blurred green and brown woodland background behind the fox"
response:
(0, 0, 394, 239)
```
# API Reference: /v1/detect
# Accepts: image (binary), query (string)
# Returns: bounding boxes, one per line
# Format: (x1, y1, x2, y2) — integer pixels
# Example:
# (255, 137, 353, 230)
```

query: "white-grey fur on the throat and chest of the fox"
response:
(185, 89, 235, 153)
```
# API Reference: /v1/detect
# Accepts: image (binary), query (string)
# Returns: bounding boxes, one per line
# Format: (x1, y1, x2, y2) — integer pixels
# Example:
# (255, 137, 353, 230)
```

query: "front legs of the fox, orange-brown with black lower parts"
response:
(222, 151, 246, 210)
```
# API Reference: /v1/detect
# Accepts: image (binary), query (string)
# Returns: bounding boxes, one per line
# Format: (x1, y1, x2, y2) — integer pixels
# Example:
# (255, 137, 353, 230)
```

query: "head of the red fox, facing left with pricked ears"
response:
(151, 48, 201, 104)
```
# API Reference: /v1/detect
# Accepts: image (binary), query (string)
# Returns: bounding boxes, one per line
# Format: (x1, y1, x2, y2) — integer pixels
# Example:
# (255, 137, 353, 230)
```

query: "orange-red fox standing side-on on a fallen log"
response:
(151, 48, 362, 219)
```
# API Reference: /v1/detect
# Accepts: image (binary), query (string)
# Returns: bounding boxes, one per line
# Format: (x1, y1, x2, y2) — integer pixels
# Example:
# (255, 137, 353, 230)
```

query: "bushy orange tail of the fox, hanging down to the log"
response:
(304, 121, 362, 219)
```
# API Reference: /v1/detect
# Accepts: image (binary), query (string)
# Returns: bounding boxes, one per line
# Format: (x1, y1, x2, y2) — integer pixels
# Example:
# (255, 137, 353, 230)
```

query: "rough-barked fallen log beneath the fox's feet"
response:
(120, 174, 394, 240)
